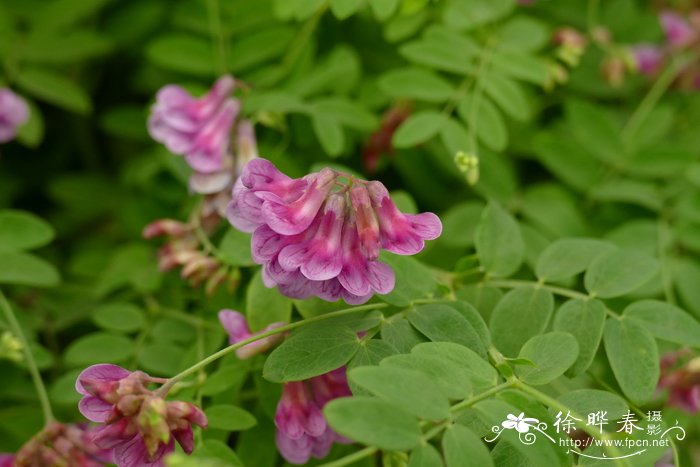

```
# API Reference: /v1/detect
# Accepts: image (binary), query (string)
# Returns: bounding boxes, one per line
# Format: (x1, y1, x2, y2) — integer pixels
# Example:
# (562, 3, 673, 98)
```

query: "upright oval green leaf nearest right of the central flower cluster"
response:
(474, 201, 525, 277)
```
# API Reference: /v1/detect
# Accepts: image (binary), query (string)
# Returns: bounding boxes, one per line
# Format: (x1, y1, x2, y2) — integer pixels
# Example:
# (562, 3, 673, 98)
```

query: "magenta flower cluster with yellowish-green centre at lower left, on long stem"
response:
(75, 364, 207, 467)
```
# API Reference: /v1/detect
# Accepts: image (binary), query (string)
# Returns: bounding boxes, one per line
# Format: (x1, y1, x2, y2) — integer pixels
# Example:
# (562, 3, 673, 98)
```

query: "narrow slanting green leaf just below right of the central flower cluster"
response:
(406, 304, 486, 356)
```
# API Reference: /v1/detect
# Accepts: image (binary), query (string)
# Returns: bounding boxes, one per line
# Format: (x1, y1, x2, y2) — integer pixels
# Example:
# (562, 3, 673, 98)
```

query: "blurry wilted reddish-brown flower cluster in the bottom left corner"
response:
(0, 422, 112, 467)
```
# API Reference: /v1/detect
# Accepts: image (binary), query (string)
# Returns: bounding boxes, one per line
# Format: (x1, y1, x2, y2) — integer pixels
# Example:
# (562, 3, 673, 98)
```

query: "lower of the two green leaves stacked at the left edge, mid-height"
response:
(0, 251, 61, 287)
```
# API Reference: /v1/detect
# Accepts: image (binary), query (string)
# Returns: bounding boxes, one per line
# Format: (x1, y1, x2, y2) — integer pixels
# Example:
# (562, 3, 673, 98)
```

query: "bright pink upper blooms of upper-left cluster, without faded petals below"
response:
(148, 76, 240, 174)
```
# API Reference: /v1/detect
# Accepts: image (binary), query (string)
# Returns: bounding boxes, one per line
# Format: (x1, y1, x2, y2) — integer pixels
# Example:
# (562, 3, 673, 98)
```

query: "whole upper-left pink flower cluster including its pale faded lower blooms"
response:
(148, 75, 257, 211)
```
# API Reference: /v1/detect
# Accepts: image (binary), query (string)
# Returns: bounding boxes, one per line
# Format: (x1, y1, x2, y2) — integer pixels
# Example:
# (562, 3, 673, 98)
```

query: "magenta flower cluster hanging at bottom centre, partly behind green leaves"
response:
(275, 368, 351, 464)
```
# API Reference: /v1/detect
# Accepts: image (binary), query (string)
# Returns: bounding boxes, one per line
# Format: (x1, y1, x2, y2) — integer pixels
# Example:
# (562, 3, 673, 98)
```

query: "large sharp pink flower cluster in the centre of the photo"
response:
(228, 158, 442, 305)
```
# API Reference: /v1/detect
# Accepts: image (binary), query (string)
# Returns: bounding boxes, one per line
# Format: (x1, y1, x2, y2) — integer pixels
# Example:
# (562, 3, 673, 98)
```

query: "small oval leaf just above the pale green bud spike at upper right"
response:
(457, 96, 508, 151)
